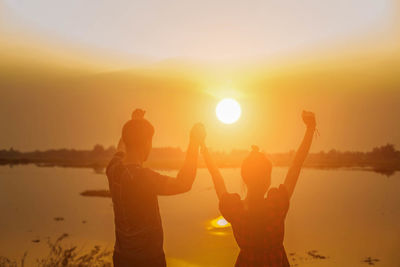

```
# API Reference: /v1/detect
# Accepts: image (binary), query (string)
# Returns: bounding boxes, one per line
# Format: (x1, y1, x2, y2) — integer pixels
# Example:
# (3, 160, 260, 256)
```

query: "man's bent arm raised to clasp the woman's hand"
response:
(159, 123, 206, 195)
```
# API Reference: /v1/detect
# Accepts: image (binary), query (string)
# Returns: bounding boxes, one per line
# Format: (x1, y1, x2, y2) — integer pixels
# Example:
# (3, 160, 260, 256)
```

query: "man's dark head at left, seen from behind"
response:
(122, 109, 154, 161)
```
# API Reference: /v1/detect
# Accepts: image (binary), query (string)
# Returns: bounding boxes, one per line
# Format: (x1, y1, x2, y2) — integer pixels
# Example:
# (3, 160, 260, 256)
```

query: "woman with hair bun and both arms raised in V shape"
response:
(202, 111, 316, 267)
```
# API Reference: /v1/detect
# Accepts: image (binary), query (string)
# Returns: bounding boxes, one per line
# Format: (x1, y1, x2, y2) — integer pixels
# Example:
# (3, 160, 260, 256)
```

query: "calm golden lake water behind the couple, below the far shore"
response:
(0, 165, 400, 266)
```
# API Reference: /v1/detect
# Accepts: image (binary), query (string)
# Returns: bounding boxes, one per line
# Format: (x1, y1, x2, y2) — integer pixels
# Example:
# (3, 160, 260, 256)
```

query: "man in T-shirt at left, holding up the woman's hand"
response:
(106, 109, 205, 267)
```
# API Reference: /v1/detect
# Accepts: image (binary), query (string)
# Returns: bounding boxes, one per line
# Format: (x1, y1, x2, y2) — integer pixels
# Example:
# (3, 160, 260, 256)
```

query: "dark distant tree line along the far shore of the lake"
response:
(0, 144, 400, 175)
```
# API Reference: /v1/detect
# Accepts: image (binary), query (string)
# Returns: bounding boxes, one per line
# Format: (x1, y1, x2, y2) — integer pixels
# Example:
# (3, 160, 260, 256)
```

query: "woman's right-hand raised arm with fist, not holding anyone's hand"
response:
(285, 111, 316, 197)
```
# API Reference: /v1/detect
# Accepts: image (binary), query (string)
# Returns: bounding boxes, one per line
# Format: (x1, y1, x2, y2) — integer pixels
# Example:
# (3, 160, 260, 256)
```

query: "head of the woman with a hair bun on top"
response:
(241, 146, 272, 195)
